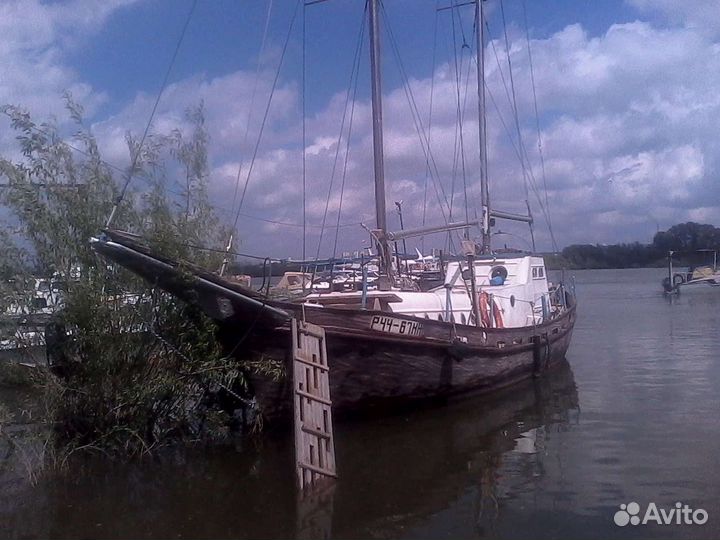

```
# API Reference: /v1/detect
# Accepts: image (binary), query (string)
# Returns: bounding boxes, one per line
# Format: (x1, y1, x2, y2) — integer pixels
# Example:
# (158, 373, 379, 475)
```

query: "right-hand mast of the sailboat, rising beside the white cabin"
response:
(475, 0, 491, 253)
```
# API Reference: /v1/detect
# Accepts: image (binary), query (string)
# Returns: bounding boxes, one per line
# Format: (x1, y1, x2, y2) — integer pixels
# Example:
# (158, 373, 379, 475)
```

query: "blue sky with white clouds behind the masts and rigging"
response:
(0, 0, 720, 257)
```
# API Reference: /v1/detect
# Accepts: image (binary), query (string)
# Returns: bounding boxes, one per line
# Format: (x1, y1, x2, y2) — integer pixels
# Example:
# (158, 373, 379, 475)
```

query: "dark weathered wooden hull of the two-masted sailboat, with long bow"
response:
(94, 231, 576, 421)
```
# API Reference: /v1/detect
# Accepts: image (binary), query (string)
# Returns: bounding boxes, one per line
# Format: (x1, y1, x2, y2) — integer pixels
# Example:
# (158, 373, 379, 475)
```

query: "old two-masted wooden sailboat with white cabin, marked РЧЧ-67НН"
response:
(92, 0, 576, 419)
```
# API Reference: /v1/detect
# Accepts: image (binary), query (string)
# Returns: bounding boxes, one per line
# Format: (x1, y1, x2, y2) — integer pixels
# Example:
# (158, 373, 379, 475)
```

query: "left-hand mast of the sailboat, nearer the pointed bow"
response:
(368, 0, 392, 273)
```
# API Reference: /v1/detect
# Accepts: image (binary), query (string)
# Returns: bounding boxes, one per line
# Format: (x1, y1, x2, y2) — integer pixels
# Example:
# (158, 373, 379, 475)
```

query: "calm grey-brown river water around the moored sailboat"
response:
(0, 269, 720, 539)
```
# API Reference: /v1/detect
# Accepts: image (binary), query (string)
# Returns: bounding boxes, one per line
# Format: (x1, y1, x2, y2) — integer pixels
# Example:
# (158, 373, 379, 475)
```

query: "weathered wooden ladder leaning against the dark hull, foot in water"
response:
(292, 319, 337, 490)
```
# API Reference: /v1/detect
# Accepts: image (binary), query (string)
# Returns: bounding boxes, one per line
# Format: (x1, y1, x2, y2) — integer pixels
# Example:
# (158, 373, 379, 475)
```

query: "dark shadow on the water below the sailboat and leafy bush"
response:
(0, 363, 578, 538)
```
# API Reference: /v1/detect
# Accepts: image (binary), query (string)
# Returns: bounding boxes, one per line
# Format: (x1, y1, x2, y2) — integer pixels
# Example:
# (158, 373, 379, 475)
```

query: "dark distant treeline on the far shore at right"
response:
(548, 222, 720, 269)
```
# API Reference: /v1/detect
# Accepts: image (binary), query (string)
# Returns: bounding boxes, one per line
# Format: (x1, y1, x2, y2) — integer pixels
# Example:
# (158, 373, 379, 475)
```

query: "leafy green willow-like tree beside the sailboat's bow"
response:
(0, 96, 250, 453)
